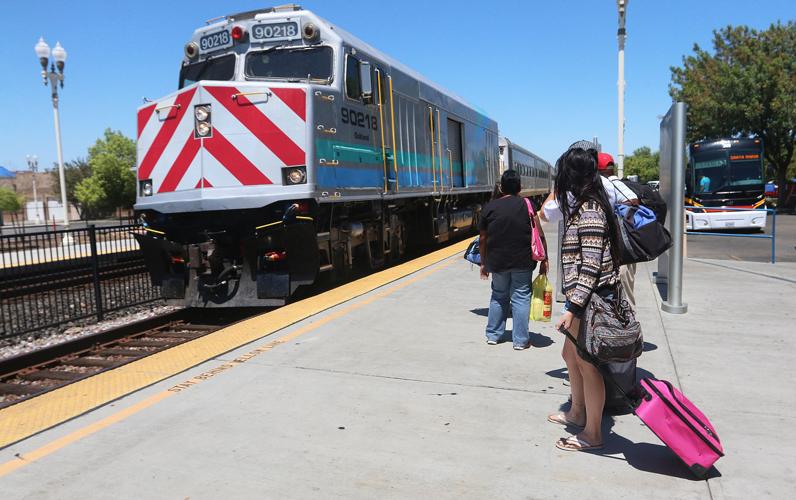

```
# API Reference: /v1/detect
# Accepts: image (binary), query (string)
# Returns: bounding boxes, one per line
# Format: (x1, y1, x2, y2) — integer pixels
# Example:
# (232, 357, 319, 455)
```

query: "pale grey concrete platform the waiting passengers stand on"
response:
(0, 224, 796, 499)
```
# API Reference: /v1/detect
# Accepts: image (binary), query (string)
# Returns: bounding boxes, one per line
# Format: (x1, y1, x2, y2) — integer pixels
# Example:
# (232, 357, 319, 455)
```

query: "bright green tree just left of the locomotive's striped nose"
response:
(75, 129, 135, 213)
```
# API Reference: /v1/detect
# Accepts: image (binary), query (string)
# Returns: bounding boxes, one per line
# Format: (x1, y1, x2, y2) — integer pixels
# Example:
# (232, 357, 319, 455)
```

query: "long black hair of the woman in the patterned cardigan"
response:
(556, 148, 620, 266)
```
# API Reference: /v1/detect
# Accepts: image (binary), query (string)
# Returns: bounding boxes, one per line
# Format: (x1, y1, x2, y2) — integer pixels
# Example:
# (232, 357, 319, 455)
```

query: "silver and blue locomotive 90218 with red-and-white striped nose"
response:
(135, 5, 499, 306)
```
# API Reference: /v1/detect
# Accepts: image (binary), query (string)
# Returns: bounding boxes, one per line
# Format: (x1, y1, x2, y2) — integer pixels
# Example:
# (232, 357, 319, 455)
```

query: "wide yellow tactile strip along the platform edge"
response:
(0, 241, 469, 450)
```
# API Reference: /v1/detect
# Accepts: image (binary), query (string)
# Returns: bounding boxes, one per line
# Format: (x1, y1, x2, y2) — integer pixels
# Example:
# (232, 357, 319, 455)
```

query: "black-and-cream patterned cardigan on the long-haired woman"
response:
(561, 201, 619, 317)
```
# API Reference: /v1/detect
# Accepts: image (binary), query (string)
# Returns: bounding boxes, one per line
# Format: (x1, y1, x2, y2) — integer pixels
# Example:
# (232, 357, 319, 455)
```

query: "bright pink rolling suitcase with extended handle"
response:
(561, 328, 724, 478)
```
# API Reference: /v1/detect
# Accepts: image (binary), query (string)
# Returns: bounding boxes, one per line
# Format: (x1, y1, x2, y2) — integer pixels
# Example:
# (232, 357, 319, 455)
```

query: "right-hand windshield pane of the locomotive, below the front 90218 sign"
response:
(246, 46, 332, 82)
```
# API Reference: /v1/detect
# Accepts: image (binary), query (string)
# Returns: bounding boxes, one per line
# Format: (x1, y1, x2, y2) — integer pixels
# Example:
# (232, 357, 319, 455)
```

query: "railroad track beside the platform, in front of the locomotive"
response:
(0, 309, 257, 408)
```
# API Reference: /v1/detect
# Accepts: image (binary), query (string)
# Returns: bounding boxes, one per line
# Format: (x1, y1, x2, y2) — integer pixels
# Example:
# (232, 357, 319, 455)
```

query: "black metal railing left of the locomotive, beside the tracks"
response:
(0, 224, 160, 338)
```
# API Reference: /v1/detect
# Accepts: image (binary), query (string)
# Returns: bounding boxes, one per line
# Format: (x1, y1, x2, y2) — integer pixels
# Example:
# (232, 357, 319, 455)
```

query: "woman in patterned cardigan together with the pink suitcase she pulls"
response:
(548, 141, 724, 478)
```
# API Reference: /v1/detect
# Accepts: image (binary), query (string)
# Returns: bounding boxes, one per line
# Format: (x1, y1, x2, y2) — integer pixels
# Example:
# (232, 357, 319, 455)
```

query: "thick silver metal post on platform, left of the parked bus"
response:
(661, 102, 688, 314)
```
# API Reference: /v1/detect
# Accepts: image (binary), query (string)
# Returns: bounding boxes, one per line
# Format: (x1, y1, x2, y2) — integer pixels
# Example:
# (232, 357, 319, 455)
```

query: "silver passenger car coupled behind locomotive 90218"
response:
(498, 137, 555, 206)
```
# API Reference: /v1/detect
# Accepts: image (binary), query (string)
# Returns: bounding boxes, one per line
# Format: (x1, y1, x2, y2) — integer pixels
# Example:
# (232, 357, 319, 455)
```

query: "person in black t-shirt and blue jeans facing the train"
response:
(479, 170, 547, 350)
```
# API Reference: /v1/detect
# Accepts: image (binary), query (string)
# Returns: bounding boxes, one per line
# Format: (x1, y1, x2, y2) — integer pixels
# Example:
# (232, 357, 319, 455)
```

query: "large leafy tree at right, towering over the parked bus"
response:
(669, 21, 796, 202)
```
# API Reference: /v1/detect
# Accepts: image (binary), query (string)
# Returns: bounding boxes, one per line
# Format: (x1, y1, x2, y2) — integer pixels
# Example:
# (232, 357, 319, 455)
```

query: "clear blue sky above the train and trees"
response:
(0, 0, 796, 170)
